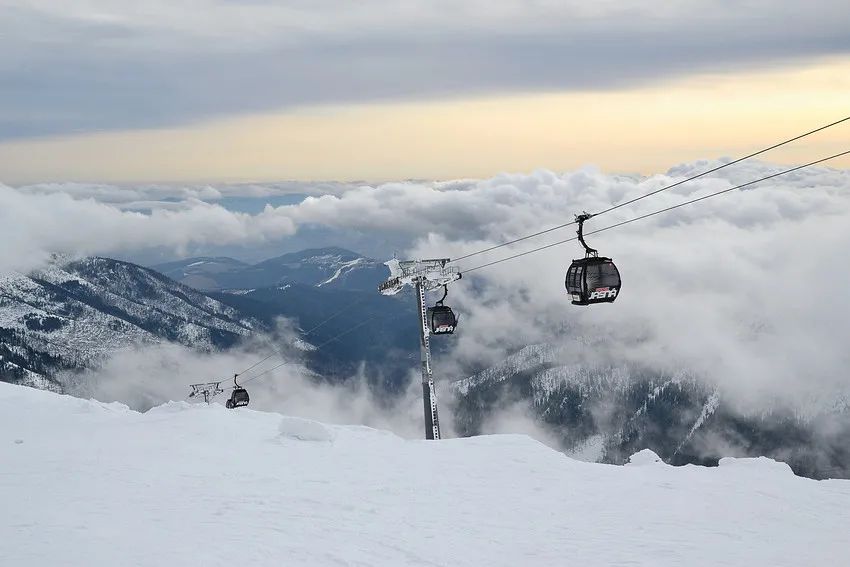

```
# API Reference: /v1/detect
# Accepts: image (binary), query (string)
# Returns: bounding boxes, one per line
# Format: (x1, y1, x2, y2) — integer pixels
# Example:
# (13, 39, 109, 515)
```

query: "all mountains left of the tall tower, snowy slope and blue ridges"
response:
(0, 248, 418, 391)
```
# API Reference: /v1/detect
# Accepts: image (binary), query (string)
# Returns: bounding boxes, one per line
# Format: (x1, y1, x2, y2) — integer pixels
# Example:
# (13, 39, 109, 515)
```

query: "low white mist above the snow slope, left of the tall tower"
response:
(68, 337, 430, 438)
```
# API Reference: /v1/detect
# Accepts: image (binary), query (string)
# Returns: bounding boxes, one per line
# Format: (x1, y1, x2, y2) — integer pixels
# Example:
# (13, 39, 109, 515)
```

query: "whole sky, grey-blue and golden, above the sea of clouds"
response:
(0, 0, 850, 185)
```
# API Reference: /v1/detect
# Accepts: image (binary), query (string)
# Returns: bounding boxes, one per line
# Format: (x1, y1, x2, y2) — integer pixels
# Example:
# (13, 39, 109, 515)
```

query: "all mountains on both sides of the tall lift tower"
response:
(0, 248, 850, 478)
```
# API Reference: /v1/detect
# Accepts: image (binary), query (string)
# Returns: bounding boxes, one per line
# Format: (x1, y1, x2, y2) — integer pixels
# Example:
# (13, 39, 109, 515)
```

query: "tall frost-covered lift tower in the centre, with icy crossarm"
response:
(378, 258, 460, 439)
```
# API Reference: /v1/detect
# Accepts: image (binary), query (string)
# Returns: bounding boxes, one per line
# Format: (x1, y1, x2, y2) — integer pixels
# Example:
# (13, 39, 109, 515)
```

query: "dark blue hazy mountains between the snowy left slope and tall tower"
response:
(156, 247, 420, 390)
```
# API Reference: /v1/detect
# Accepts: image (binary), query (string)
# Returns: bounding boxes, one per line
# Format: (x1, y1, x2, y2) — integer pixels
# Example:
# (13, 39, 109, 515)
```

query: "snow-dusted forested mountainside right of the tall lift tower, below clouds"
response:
(453, 344, 850, 478)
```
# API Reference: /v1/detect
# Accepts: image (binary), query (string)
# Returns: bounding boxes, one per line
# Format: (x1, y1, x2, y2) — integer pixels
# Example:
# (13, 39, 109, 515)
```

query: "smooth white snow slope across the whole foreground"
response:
(0, 383, 850, 567)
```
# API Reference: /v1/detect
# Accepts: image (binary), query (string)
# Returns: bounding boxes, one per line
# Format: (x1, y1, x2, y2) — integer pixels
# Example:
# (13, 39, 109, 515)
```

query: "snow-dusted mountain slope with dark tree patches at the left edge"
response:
(0, 258, 255, 388)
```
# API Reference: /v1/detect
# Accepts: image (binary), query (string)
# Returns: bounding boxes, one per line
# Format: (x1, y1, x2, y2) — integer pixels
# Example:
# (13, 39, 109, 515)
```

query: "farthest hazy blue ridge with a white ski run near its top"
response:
(154, 247, 387, 292)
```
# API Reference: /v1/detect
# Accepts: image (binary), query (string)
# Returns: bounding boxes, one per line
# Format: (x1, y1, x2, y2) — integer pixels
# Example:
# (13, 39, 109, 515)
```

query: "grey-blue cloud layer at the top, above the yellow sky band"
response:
(0, 0, 850, 139)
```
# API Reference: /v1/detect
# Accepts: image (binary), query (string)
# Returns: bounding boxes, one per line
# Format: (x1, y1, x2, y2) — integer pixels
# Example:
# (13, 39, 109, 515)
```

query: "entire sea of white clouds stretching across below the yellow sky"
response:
(0, 156, 850, 430)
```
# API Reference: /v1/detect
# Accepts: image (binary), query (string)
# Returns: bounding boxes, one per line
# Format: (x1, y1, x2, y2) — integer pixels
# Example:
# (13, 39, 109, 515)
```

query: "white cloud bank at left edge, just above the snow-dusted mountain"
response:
(0, 185, 295, 274)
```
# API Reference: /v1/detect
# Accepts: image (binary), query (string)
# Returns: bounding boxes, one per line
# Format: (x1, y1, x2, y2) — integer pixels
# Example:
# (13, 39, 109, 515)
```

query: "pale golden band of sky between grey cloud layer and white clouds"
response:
(0, 57, 850, 184)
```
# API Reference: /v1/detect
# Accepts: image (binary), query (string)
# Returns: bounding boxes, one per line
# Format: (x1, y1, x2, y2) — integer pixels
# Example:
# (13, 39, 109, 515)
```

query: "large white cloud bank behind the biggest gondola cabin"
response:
(280, 162, 850, 412)
